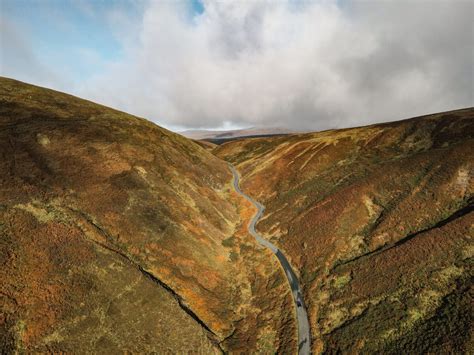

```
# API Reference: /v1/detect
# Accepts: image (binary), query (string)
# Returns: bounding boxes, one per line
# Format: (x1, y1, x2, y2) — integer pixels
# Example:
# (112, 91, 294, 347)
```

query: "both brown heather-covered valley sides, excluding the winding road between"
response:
(0, 78, 474, 354)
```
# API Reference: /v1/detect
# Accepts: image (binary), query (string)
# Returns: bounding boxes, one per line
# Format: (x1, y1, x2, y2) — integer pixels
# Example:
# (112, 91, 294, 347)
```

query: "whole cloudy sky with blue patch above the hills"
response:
(0, 0, 474, 130)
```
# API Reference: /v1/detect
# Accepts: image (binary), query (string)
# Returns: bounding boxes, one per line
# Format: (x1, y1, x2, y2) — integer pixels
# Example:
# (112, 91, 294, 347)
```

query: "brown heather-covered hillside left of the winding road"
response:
(0, 78, 294, 353)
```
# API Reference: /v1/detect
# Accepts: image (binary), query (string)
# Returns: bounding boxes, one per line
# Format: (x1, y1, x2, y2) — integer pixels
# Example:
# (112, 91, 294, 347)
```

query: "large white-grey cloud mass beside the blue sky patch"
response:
(5, 0, 474, 129)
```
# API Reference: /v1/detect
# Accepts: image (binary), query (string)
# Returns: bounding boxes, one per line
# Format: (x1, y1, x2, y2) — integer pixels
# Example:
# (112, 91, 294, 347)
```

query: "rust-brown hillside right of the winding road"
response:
(214, 109, 474, 353)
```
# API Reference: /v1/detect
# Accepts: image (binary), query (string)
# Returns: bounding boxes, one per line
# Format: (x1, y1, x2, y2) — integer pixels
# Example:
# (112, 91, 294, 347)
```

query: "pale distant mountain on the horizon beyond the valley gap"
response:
(178, 127, 296, 140)
